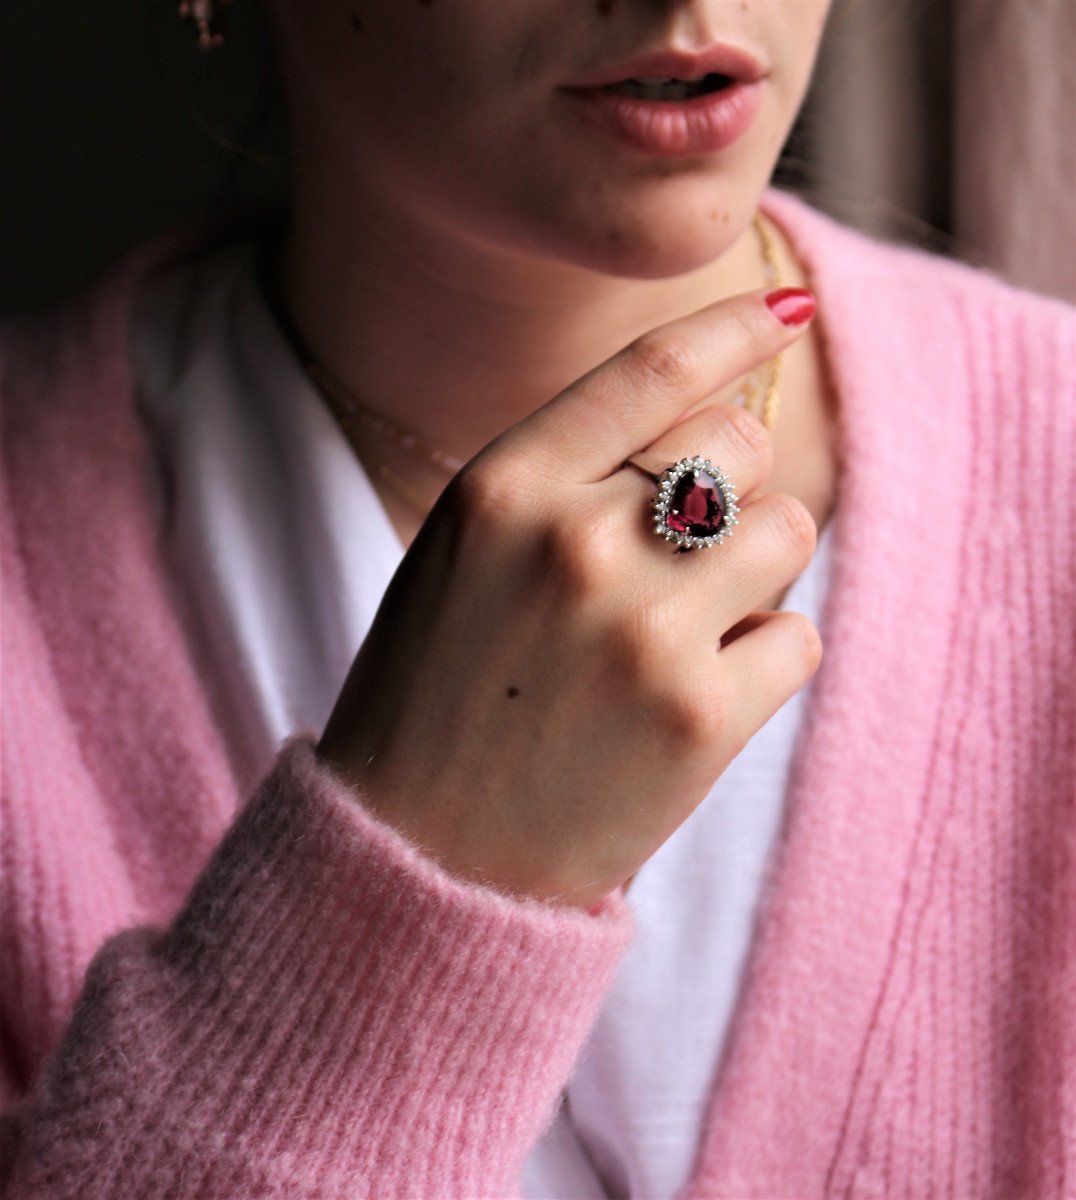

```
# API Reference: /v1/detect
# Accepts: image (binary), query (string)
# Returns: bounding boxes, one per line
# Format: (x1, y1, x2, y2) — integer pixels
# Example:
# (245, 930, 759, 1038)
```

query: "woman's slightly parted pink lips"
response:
(561, 46, 765, 157)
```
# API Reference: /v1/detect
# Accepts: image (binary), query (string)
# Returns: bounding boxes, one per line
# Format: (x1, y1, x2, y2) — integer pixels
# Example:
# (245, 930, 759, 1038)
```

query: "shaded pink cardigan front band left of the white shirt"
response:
(5, 224, 247, 921)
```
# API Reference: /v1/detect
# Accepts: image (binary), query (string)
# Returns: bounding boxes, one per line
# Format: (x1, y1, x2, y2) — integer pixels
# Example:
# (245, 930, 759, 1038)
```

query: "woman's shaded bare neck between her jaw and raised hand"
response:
(268, 188, 767, 472)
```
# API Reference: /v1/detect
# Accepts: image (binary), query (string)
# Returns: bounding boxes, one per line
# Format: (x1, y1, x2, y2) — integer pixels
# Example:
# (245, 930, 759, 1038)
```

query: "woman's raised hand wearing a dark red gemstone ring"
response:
(318, 292, 822, 907)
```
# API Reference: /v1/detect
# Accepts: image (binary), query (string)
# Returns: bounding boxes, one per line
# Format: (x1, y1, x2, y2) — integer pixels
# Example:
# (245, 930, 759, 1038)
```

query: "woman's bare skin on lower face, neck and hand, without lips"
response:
(262, 0, 835, 906)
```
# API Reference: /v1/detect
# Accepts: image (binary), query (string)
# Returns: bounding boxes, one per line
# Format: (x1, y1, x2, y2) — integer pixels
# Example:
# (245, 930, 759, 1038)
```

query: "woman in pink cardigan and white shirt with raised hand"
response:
(2, 0, 1076, 1198)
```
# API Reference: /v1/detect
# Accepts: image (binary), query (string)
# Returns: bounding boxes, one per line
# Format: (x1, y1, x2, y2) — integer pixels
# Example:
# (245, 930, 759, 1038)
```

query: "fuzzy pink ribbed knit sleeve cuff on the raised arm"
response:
(0, 738, 631, 1200)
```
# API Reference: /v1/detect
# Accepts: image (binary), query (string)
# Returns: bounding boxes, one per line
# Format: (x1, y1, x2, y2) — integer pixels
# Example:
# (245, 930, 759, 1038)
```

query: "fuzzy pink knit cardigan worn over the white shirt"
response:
(0, 192, 1076, 1200)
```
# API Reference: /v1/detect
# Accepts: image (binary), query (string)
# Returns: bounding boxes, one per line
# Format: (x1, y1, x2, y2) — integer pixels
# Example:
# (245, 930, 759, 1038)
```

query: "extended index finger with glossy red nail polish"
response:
(501, 288, 814, 482)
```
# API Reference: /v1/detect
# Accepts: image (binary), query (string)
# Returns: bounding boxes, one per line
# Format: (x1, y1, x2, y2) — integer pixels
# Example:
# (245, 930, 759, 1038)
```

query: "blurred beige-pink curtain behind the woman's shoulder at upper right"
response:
(791, 0, 1076, 302)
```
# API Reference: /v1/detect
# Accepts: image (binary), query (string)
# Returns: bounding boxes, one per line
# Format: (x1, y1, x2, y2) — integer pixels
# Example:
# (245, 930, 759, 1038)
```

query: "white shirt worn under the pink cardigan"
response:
(134, 244, 831, 1200)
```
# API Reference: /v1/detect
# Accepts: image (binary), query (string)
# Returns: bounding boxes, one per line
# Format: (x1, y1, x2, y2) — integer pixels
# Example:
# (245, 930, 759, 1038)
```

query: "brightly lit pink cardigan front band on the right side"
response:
(687, 192, 972, 1196)
